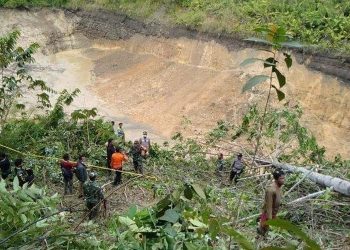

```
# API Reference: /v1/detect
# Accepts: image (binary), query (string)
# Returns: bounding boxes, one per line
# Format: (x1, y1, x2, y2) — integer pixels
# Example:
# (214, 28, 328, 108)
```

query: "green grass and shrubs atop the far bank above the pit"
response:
(0, 0, 350, 53)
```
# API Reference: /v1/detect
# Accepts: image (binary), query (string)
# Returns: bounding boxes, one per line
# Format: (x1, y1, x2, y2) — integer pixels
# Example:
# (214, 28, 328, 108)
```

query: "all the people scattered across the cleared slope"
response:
(0, 122, 285, 230)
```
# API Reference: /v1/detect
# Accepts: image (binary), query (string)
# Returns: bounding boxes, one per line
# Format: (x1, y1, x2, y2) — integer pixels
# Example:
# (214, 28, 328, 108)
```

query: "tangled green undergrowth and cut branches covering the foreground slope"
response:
(0, 16, 350, 249)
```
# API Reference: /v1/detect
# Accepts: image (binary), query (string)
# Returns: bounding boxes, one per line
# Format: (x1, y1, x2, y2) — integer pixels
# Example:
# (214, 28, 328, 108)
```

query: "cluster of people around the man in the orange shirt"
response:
(59, 127, 151, 219)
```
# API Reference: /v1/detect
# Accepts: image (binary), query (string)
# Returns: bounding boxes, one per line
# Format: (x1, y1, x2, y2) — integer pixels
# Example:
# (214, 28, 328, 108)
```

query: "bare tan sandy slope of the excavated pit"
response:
(0, 11, 350, 158)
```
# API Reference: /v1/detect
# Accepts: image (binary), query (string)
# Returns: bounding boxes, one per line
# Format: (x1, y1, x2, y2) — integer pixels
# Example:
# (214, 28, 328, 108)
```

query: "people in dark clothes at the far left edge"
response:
(0, 152, 35, 187)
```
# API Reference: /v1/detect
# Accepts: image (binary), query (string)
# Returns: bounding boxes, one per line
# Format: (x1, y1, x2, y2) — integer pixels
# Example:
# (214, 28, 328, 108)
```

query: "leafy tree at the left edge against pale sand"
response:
(0, 30, 54, 129)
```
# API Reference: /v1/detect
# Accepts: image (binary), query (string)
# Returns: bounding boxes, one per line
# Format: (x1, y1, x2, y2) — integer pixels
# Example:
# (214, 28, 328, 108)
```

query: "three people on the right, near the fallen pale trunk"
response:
(216, 153, 285, 236)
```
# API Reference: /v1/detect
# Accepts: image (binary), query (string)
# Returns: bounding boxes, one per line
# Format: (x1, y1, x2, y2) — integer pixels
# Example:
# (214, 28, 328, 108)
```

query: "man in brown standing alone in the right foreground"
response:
(258, 169, 285, 236)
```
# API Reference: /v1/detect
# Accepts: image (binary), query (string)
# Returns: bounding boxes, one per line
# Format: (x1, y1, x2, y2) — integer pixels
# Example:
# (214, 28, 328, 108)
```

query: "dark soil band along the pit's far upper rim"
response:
(66, 10, 350, 83)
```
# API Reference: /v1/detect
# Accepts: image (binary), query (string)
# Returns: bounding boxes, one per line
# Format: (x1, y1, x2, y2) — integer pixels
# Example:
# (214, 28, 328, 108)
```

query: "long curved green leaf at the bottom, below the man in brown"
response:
(267, 219, 321, 250)
